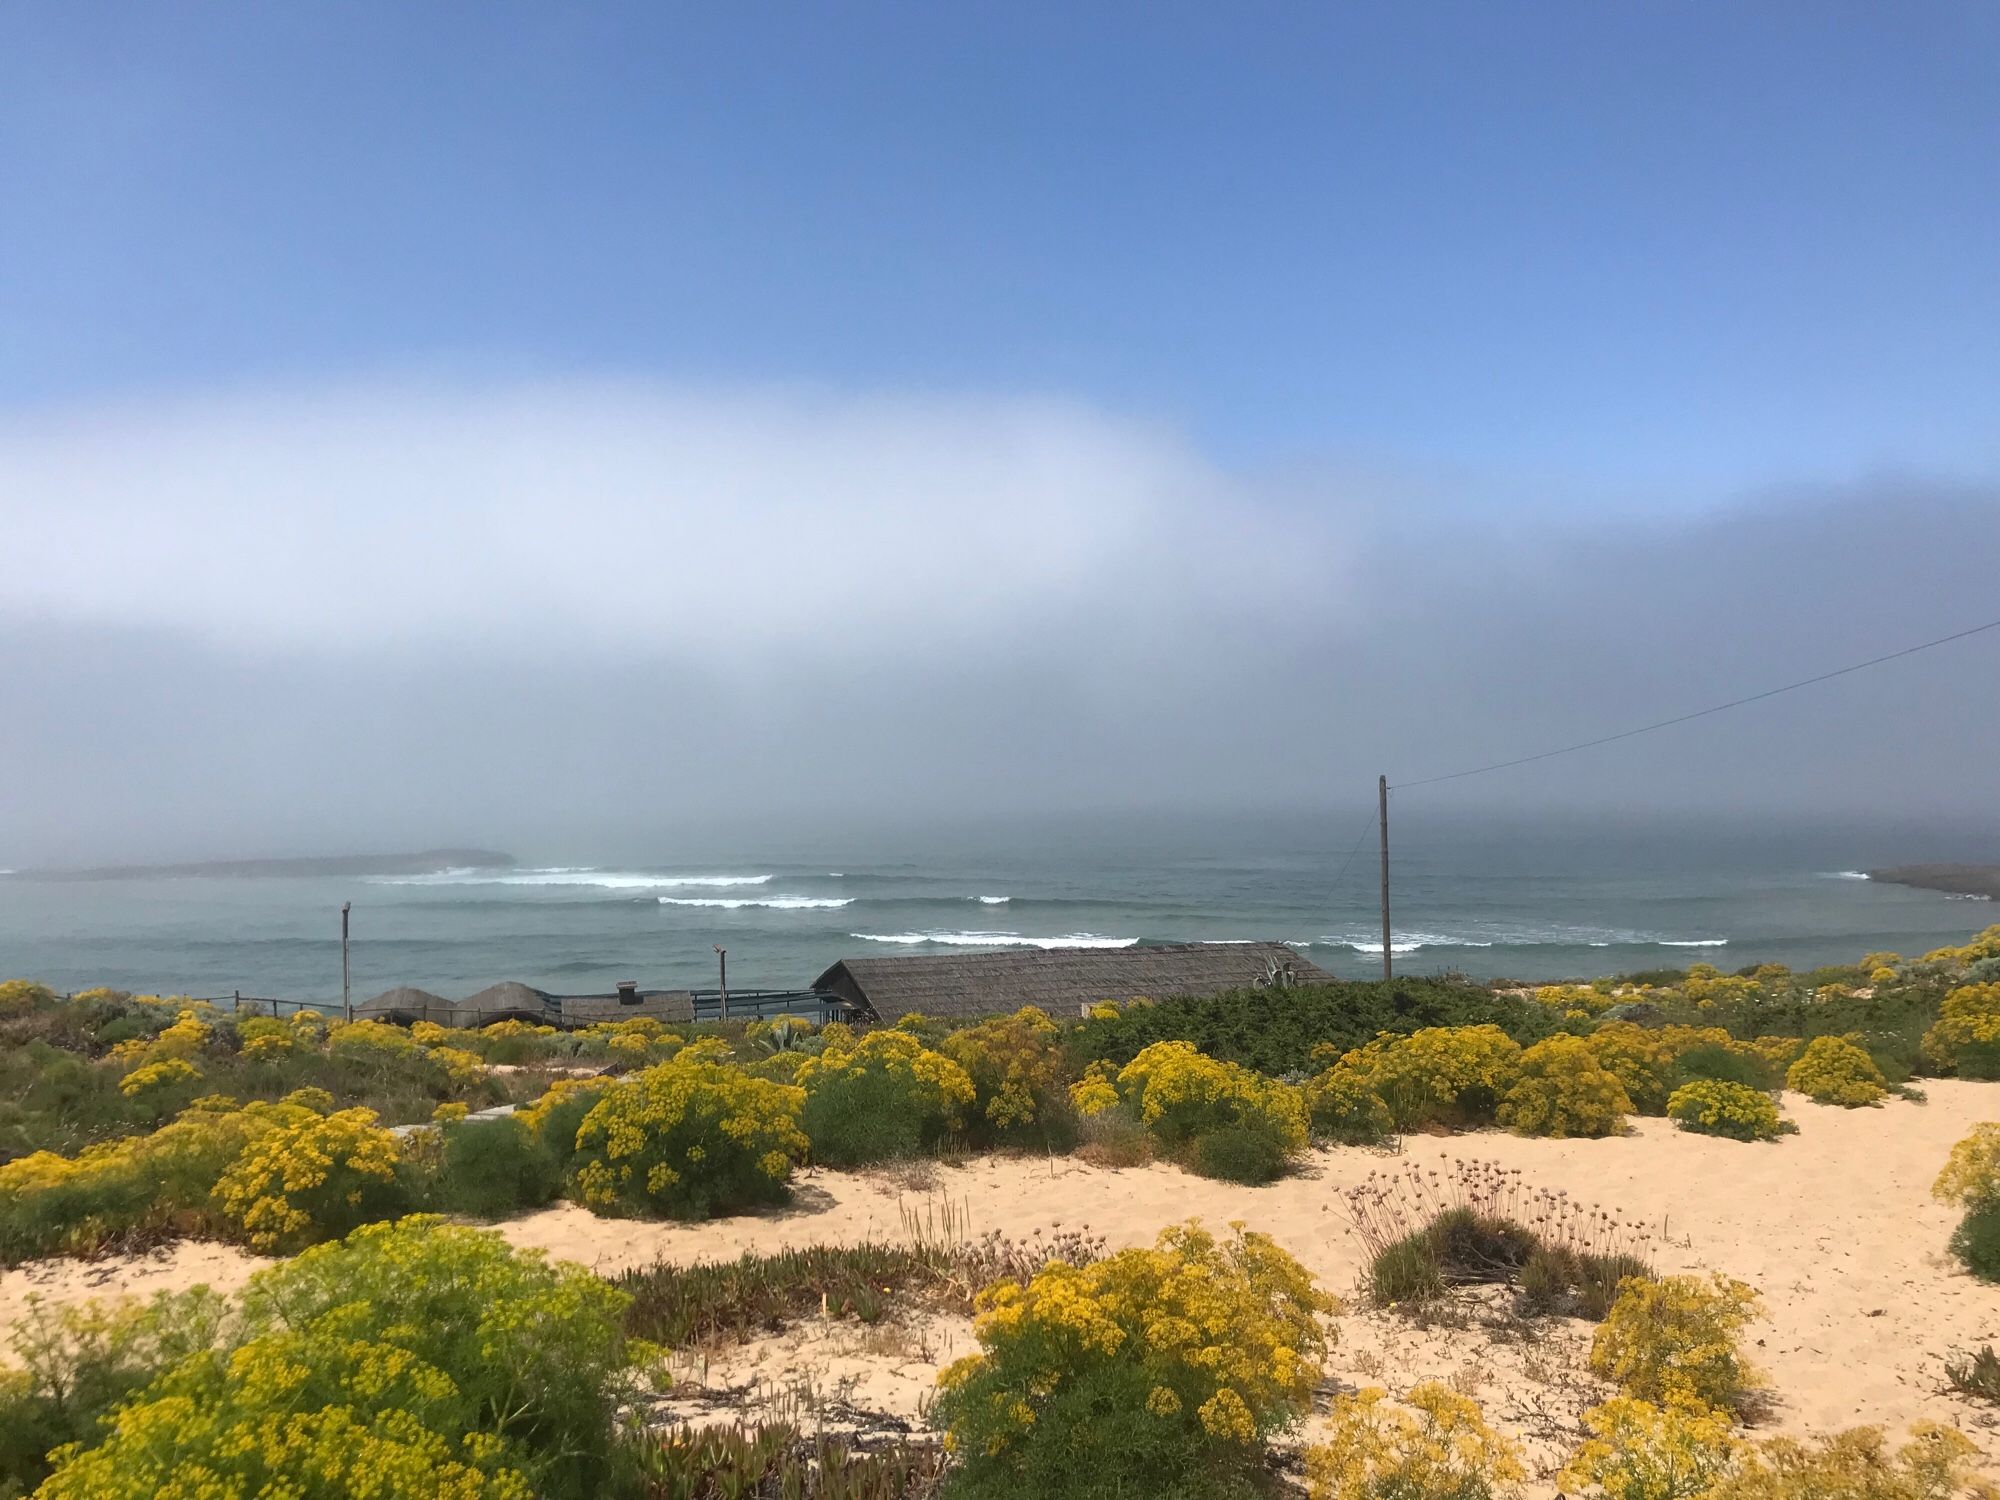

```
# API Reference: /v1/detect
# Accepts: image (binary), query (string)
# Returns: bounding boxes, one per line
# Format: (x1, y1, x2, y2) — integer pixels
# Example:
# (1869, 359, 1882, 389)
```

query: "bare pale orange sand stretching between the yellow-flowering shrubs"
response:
(0, 1082, 2000, 1460)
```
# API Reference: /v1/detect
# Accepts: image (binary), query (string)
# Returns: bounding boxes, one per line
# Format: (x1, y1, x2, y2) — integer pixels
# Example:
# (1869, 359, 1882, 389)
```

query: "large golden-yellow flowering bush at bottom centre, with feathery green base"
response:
(936, 1224, 1334, 1498)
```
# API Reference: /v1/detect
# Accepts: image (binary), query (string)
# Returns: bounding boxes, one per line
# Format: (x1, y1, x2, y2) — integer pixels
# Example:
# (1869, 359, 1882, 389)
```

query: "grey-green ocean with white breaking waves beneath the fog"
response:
(0, 806, 2000, 1000)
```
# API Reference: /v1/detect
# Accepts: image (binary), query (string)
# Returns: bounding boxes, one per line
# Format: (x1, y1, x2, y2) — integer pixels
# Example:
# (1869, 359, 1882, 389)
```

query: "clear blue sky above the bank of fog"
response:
(0, 0, 2000, 500)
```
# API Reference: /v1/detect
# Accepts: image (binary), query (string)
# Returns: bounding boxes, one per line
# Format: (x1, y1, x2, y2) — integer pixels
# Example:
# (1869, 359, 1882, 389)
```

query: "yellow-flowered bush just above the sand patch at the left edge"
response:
(216, 1110, 404, 1250)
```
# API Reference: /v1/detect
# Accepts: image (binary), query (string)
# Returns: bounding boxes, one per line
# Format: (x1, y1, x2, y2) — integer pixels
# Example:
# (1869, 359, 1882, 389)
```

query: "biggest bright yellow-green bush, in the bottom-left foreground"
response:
(42, 1218, 630, 1500)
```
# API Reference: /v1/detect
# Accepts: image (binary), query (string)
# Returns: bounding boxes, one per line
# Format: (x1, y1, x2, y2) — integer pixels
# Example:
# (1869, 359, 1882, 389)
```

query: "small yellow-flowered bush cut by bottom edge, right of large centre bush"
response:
(1306, 1382, 1526, 1500)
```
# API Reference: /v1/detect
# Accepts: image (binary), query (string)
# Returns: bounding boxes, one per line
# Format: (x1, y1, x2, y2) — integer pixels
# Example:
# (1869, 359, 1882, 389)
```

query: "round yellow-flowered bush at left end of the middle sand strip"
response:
(576, 1056, 806, 1218)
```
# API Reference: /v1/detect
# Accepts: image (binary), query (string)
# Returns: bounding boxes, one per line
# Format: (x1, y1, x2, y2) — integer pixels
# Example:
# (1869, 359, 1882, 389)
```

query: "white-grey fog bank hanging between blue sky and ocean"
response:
(0, 382, 2000, 866)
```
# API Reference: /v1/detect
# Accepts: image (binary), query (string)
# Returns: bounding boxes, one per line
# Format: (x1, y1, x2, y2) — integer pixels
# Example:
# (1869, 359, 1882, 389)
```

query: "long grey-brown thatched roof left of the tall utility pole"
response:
(812, 942, 1332, 1020)
